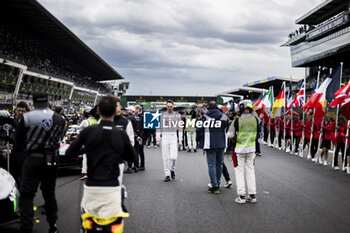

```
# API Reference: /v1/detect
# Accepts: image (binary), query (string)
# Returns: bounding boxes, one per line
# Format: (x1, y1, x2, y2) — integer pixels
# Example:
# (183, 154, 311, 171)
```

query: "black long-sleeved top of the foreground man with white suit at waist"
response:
(66, 121, 136, 186)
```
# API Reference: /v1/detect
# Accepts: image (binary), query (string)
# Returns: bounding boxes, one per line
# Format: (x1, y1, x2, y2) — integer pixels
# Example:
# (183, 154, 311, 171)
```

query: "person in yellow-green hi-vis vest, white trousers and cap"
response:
(229, 100, 259, 204)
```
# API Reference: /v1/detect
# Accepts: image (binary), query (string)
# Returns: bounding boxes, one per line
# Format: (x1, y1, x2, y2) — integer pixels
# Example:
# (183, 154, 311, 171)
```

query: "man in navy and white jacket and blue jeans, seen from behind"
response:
(196, 101, 228, 194)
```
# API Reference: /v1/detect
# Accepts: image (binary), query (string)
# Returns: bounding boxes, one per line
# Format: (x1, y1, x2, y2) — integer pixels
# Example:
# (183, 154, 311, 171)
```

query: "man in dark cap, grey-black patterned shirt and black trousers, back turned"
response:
(15, 94, 65, 233)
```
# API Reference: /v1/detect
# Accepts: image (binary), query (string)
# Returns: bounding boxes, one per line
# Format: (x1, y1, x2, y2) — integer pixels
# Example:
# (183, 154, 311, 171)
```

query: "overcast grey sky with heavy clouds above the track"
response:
(39, 0, 322, 95)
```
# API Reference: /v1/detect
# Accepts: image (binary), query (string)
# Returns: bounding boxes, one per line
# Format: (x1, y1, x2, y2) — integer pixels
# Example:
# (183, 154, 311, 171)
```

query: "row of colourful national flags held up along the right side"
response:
(253, 66, 350, 121)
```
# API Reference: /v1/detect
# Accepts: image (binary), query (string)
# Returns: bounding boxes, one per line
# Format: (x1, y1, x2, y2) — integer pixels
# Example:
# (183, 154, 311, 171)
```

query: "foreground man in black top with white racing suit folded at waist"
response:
(66, 95, 136, 228)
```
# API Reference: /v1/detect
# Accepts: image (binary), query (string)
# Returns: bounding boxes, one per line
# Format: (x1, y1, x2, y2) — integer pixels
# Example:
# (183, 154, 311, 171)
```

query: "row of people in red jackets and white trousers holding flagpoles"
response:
(261, 111, 349, 172)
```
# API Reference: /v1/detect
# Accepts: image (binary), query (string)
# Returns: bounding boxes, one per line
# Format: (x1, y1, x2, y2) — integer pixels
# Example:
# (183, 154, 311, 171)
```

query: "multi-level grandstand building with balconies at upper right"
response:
(282, 0, 350, 89)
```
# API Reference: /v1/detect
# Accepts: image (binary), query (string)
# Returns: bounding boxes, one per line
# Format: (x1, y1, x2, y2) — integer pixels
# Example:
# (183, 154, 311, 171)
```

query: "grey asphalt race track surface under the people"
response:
(0, 146, 350, 233)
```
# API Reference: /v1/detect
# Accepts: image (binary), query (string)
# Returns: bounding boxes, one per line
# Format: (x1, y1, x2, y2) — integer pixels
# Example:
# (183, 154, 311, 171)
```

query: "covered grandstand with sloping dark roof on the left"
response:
(0, 0, 123, 108)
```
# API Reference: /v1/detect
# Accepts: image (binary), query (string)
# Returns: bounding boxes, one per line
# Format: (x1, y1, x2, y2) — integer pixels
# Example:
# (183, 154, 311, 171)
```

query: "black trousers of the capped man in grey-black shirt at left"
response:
(19, 155, 57, 232)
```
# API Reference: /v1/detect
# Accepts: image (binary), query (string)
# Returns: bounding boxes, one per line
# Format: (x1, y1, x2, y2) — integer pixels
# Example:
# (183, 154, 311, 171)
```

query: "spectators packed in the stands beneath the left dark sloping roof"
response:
(0, 29, 111, 94)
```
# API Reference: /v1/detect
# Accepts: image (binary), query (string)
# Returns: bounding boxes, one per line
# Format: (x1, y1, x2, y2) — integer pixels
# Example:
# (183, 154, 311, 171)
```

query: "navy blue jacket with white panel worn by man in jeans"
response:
(196, 109, 228, 150)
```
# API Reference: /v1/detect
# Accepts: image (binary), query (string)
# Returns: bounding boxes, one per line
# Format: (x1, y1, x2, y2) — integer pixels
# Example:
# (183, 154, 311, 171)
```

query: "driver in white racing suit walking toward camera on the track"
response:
(157, 100, 182, 182)
